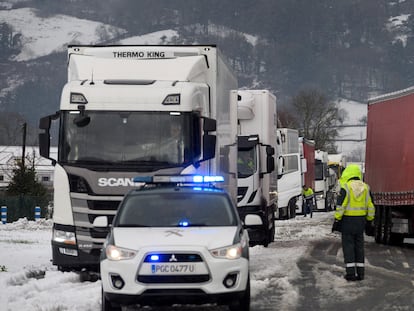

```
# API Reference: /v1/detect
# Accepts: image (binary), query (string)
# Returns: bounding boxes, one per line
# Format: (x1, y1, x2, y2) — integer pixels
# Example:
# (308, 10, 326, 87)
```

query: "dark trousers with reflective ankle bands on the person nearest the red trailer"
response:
(342, 216, 365, 278)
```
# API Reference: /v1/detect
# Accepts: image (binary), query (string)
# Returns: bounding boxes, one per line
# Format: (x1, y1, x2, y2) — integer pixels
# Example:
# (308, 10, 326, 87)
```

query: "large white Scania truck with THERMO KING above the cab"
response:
(39, 46, 237, 271)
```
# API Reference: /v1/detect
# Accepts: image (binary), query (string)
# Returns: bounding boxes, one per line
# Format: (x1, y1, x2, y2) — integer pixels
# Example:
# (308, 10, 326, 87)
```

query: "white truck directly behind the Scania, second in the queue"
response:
(237, 90, 280, 246)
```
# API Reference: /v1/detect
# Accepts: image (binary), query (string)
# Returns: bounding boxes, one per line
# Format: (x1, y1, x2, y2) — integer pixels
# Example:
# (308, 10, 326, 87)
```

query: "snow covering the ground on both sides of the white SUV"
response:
(0, 213, 346, 311)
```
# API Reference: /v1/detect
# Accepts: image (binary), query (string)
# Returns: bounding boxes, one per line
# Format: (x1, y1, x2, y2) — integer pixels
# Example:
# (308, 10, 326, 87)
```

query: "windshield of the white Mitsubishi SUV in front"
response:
(114, 192, 237, 227)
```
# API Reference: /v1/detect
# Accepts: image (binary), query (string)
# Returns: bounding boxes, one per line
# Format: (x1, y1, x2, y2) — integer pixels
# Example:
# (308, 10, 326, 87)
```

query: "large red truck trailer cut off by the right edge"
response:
(365, 87, 414, 244)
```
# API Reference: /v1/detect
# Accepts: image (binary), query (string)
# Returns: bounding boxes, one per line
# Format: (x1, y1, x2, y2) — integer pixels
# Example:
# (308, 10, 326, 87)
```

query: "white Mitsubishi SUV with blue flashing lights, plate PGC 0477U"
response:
(94, 176, 250, 311)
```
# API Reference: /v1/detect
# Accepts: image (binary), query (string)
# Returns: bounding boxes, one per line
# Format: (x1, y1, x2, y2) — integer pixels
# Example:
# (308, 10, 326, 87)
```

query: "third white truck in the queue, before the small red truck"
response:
(277, 128, 306, 219)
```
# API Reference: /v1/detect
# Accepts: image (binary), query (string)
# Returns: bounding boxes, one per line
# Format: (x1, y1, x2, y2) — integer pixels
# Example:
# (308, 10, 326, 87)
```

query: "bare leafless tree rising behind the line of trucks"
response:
(291, 89, 343, 152)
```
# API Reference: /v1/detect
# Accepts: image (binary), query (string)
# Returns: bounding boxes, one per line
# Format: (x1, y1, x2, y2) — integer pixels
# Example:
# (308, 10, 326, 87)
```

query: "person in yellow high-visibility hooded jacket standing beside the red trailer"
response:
(332, 164, 375, 281)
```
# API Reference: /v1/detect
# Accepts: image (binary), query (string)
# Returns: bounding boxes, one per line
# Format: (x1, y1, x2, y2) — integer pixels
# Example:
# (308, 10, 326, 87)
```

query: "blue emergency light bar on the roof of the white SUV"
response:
(134, 175, 224, 184)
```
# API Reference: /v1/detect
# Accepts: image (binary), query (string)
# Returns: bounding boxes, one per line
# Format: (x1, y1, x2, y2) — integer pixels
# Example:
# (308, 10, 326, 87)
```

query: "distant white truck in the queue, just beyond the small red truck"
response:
(314, 150, 337, 211)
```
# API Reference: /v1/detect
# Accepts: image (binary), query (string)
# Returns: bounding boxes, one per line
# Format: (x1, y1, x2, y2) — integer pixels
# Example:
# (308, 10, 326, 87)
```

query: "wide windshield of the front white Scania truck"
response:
(59, 111, 200, 169)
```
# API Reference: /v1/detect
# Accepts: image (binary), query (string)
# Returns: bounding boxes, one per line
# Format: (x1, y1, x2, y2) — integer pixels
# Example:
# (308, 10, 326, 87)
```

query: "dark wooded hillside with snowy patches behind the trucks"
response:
(0, 0, 414, 156)
